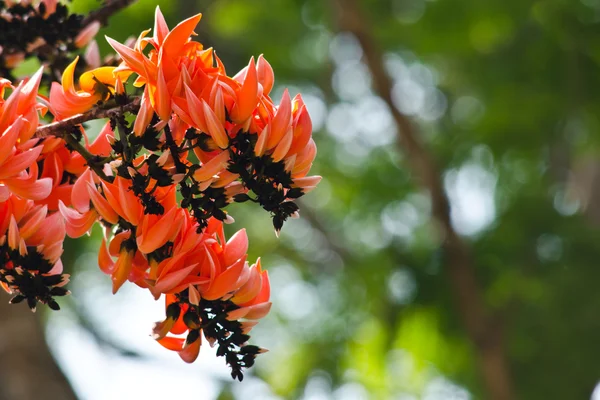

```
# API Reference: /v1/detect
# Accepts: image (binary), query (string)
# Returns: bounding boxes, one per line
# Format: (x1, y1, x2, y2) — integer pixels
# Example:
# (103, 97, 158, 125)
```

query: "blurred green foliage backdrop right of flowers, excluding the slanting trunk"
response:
(57, 0, 600, 399)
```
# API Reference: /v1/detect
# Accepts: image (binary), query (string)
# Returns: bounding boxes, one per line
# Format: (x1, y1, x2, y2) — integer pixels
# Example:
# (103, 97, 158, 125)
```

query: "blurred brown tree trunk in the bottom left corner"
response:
(0, 295, 77, 400)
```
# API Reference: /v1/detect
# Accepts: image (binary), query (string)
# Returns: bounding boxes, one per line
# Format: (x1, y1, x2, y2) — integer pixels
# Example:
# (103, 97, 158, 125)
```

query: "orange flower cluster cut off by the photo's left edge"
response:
(0, 69, 110, 310)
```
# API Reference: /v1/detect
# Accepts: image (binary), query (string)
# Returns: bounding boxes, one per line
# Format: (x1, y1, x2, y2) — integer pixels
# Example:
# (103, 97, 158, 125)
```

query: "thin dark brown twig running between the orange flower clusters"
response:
(35, 97, 141, 138)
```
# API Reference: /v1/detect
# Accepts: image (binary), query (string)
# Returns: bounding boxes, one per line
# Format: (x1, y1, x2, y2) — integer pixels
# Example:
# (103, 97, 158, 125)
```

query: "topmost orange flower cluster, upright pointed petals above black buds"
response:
(107, 8, 320, 212)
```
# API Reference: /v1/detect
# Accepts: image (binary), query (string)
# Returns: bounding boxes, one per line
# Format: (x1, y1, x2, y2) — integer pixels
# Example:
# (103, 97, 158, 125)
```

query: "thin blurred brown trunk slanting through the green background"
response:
(332, 0, 515, 400)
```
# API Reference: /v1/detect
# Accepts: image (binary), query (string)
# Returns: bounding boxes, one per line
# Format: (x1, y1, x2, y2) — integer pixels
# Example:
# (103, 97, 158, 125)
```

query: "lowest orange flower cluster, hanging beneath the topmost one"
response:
(59, 170, 271, 368)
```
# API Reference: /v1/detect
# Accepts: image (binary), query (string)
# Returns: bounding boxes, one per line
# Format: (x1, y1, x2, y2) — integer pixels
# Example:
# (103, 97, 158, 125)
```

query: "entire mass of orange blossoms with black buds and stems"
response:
(0, 3, 321, 380)
